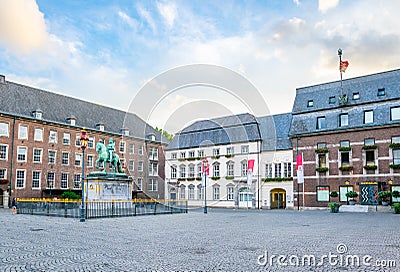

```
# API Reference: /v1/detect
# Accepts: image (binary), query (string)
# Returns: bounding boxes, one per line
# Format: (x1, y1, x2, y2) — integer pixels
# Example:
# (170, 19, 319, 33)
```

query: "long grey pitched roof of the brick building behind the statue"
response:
(0, 76, 168, 143)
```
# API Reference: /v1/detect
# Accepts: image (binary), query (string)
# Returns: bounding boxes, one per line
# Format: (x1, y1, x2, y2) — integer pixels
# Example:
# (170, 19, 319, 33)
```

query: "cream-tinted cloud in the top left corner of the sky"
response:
(0, 0, 48, 53)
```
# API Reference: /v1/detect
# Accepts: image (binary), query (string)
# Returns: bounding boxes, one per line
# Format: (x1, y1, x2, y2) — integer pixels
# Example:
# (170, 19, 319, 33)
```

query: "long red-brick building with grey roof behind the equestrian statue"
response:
(0, 76, 167, 206)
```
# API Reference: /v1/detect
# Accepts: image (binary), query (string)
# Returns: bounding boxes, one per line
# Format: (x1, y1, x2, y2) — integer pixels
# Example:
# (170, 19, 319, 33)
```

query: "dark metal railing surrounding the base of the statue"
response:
(18, 199, 188, 219)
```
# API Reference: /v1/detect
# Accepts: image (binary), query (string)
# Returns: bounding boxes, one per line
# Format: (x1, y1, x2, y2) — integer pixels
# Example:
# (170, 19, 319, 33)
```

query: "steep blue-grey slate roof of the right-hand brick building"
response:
(289, 69, 400, 135)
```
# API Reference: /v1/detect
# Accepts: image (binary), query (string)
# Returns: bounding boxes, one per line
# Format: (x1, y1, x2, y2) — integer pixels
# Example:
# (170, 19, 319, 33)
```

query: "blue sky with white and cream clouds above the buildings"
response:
(0, 0, 400, 133)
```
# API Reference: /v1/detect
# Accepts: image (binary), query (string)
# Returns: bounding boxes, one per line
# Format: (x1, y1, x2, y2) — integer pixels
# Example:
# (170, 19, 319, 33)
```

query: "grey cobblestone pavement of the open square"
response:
(0, 209, 400, 271)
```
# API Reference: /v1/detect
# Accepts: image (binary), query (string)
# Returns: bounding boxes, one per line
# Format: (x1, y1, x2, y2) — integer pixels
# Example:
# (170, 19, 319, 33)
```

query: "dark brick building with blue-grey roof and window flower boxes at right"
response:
(290, 70, 400, 207)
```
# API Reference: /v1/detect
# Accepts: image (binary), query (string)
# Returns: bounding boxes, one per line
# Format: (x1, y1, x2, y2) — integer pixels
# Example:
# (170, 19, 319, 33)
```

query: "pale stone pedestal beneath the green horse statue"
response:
(85, 172, 133, 201)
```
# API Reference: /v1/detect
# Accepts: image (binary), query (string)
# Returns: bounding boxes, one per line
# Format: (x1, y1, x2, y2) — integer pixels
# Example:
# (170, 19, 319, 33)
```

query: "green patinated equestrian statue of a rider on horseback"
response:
(96, 138, 124, 173)
